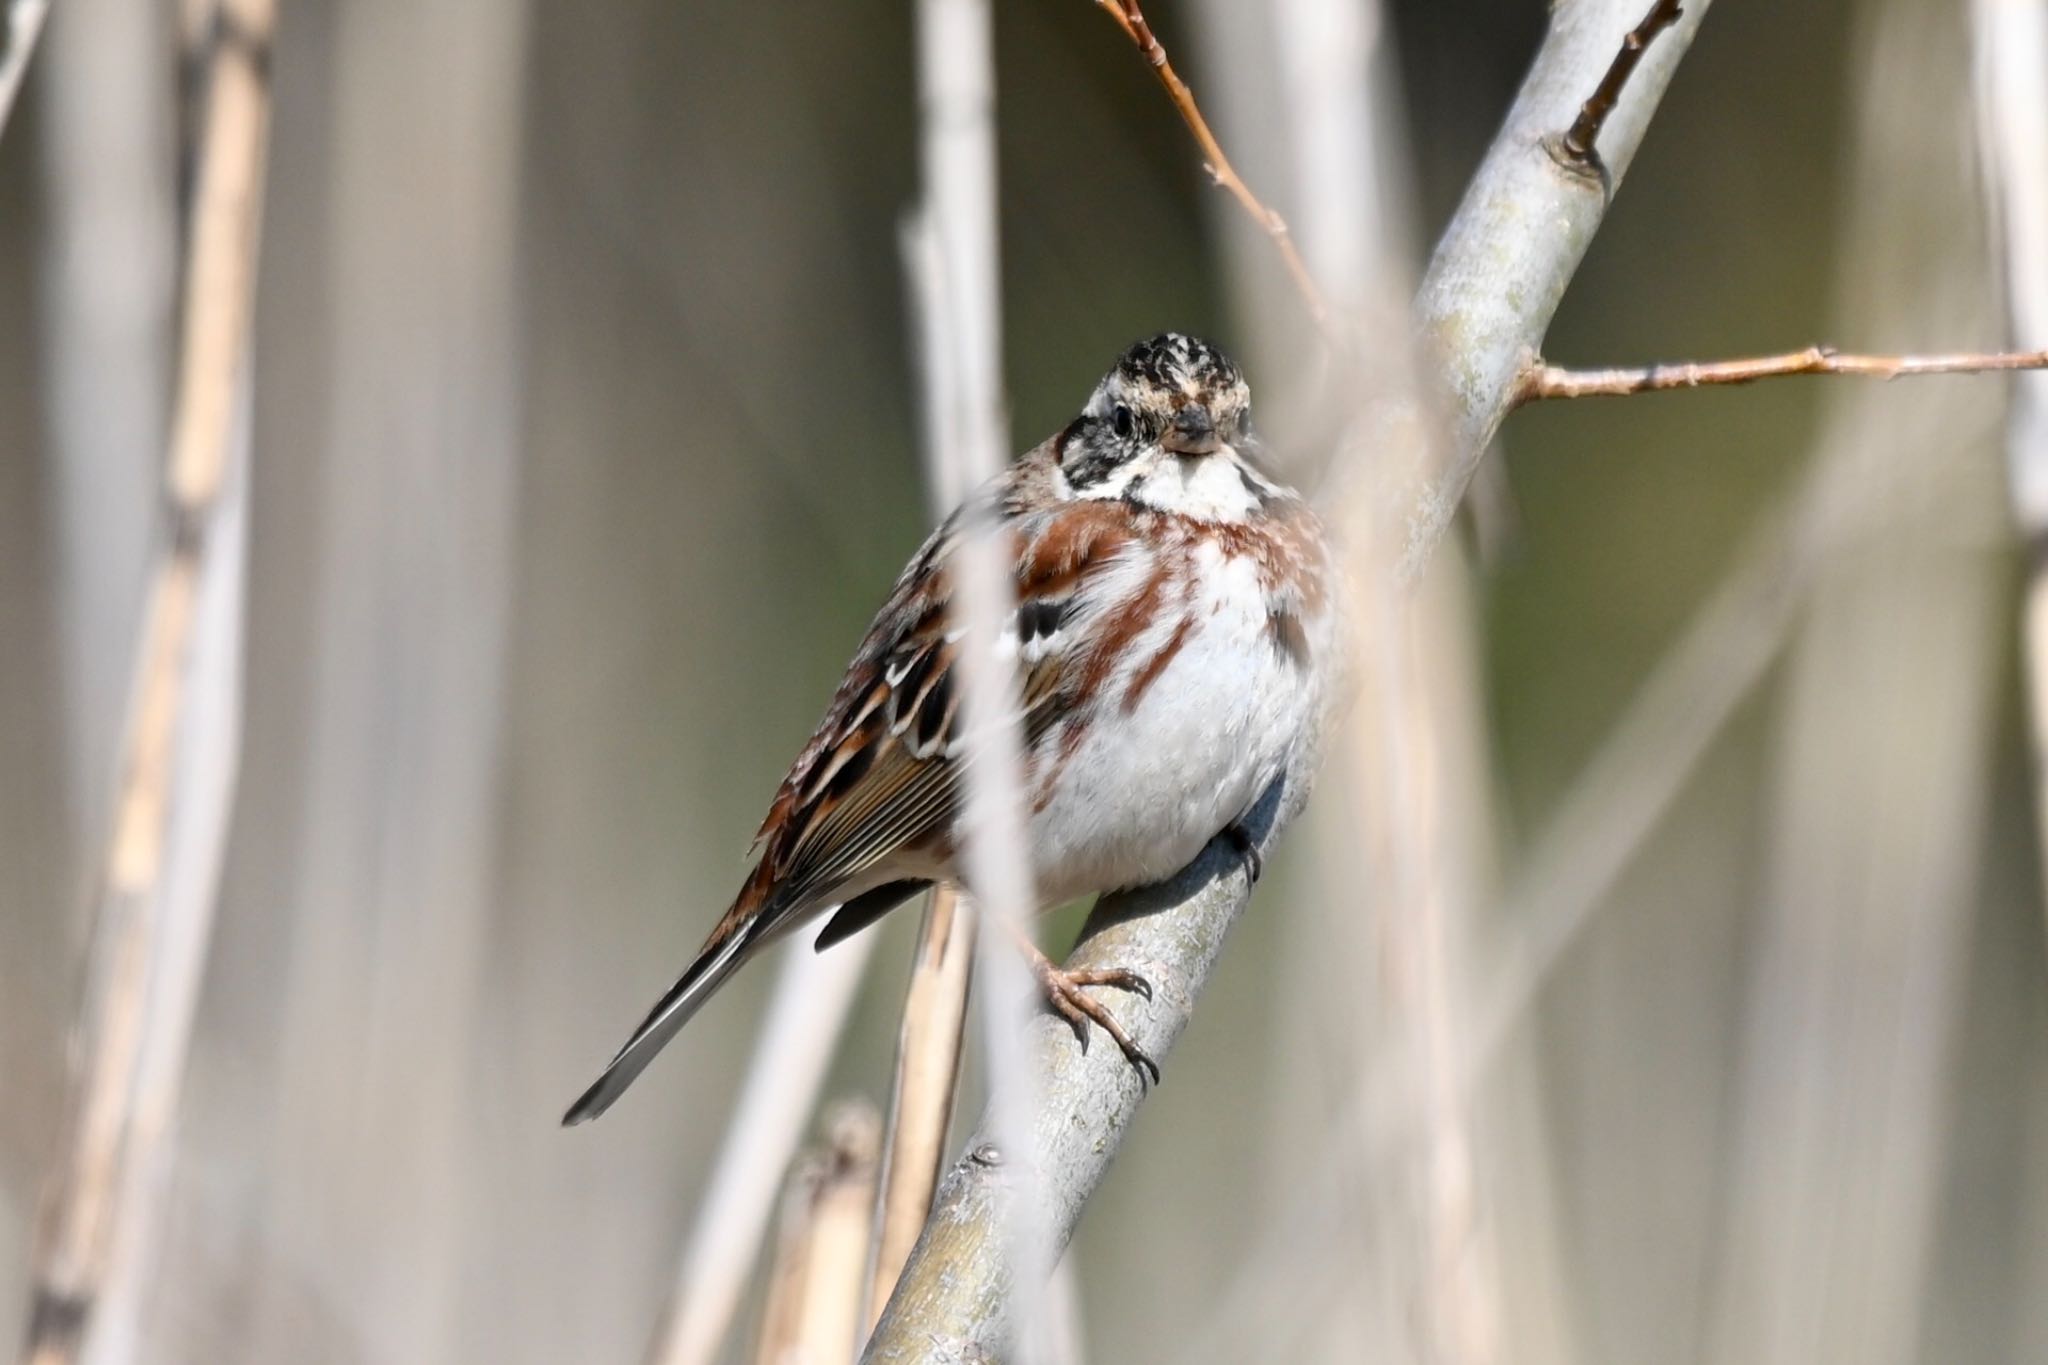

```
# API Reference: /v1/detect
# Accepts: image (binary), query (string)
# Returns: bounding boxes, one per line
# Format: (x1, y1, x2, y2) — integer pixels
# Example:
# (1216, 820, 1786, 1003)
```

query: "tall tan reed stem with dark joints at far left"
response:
(20, 0, 274, 1365)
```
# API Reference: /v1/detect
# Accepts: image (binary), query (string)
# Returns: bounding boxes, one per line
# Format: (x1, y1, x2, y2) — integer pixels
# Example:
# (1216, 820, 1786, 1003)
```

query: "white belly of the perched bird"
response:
(1030, 546, 1323, 905)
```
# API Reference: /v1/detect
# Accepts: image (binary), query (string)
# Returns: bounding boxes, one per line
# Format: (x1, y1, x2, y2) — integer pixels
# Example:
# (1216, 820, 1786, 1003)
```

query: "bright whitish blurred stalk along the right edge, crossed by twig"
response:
(1970, 0, 2048, 916)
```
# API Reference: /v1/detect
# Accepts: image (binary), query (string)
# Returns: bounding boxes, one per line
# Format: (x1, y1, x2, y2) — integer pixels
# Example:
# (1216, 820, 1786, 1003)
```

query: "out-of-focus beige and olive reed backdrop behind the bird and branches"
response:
(0, 0, 2048, 1365)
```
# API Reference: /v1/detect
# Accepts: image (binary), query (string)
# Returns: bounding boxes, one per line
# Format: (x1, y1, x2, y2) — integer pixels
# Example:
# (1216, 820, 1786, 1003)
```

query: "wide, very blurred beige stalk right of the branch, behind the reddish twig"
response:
(1704, 0, 2005, 1365)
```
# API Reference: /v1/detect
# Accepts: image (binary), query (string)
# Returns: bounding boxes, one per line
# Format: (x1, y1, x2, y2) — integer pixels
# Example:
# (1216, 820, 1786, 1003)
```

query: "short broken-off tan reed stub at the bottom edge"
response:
(754, 1101, 881, 1365)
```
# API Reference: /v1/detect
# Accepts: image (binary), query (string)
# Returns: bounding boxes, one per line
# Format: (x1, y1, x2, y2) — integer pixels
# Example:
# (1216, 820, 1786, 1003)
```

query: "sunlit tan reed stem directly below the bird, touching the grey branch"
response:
(866, 886, 975, 1330)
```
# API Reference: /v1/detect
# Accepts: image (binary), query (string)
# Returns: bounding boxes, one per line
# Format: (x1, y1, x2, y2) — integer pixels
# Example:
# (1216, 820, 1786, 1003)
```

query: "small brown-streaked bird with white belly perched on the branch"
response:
(563, 334, 1337, 1124)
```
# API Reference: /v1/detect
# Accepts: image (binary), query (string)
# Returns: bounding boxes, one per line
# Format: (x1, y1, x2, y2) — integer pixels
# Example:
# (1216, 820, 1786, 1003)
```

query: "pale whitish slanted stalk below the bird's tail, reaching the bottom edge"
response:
(647, 935, 874, 1365)
